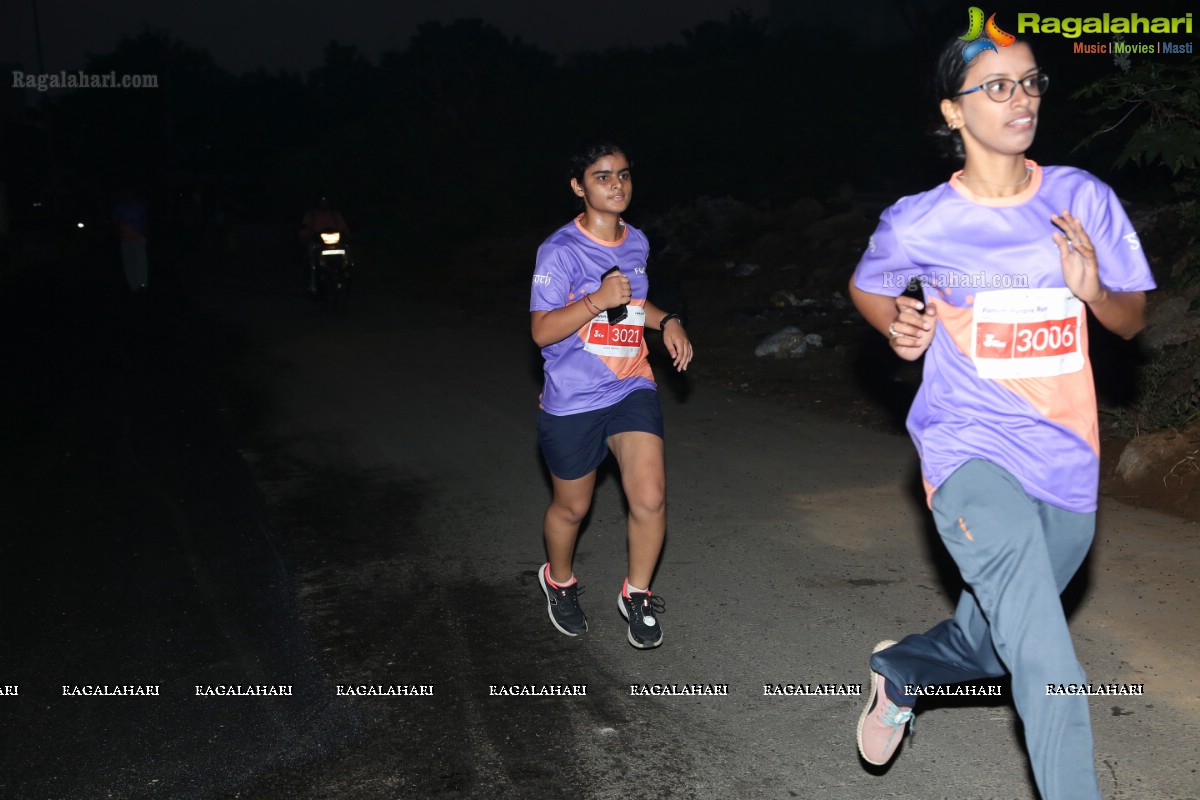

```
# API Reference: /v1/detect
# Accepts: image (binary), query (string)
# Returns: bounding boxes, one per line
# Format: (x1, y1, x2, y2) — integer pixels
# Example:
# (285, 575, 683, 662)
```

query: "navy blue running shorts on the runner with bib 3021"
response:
(538, 389, 664, 481)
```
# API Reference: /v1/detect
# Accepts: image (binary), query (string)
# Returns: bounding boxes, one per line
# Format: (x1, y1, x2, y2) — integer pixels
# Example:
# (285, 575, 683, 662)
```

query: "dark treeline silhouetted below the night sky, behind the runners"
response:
(9, 12, 926, 231)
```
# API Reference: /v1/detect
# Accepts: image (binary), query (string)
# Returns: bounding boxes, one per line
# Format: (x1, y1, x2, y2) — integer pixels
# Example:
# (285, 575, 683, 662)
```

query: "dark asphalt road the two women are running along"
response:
(0, 239, 1200, 800)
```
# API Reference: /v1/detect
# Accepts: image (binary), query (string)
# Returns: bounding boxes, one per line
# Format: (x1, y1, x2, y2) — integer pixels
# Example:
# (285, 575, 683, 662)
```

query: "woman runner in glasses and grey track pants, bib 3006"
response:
(850, 34, 1154, 800)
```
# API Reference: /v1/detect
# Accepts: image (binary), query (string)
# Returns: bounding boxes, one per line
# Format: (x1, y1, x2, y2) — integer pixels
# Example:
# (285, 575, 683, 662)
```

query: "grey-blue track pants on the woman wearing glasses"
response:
(871, 459, 1100, 800)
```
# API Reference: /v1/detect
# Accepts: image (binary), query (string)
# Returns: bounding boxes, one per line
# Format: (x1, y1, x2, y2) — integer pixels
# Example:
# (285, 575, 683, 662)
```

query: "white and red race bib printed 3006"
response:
(971, 289, 1085, 378)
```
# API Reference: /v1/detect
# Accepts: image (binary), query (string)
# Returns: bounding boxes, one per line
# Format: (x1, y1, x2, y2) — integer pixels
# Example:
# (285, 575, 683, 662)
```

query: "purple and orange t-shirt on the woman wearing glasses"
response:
(854, 162, 1154, 512)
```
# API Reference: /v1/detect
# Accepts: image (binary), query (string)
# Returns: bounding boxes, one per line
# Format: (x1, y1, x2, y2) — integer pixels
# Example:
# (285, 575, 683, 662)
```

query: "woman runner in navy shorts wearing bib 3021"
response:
(529, 142, 692, 648)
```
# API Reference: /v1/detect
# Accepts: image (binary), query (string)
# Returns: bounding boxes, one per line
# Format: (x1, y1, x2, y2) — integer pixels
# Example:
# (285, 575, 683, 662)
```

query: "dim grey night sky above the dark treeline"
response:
(0, 0, 769, 73)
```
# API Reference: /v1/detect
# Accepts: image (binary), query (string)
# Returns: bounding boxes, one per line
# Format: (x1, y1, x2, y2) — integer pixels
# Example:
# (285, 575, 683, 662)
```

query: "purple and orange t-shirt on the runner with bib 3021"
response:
(529, 215, 656, 416)
